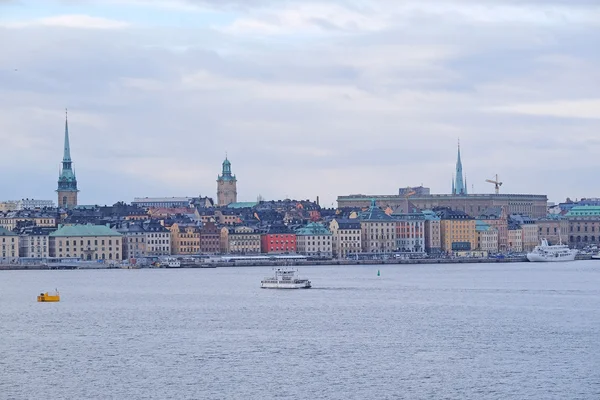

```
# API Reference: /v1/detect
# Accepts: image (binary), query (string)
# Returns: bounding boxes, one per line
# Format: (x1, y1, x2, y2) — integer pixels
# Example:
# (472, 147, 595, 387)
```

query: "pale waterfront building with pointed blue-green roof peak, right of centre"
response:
(358, 200, 397, 253)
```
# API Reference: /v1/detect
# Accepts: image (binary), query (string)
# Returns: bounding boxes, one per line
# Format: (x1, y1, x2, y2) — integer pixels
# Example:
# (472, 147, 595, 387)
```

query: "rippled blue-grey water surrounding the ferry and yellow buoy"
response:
(0, 261, 600, 400)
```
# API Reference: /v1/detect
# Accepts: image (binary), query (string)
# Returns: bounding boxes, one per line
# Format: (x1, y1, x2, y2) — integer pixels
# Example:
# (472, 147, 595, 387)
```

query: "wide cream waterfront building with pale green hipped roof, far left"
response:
(49, 224, 123, 261)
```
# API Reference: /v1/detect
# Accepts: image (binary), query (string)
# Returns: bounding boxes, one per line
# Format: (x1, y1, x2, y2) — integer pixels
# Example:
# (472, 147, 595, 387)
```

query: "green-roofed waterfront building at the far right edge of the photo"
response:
(565, 205, 600, 248)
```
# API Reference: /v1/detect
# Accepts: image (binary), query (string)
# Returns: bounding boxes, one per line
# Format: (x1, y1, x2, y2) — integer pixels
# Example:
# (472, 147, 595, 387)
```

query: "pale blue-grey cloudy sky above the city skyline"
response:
(0, 0, 600, 205)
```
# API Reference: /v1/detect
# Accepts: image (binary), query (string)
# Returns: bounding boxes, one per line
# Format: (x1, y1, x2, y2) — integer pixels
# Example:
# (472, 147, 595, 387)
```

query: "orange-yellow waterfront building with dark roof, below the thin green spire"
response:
(434, 208, 477, 253)
